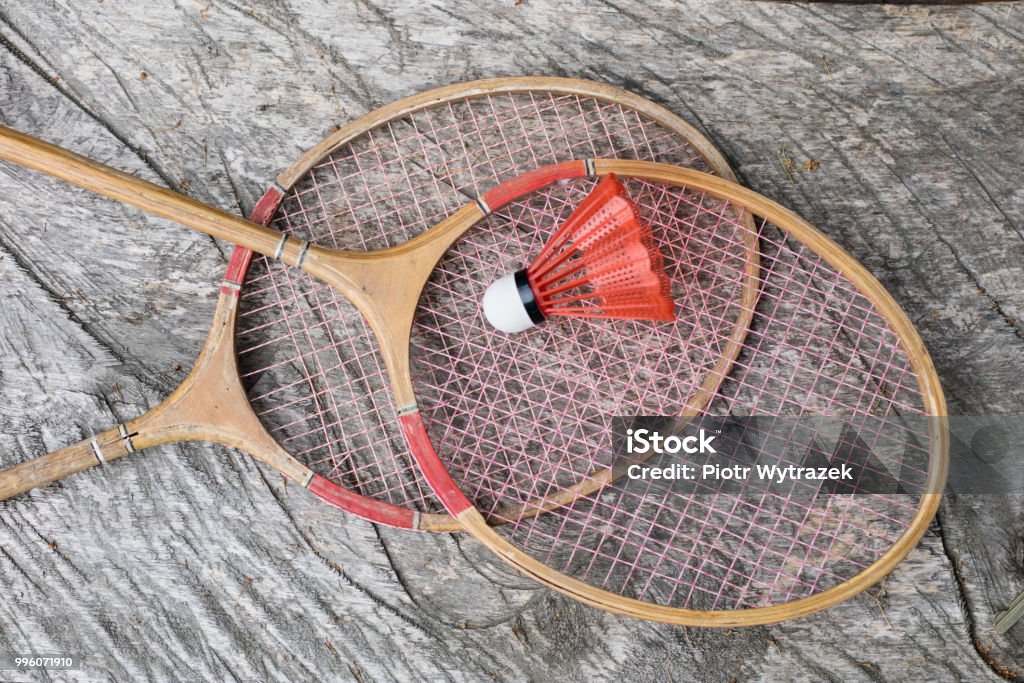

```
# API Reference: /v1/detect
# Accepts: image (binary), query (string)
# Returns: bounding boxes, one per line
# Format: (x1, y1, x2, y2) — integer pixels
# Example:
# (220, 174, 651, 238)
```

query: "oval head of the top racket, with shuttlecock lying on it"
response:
(401, 160, 948, 626)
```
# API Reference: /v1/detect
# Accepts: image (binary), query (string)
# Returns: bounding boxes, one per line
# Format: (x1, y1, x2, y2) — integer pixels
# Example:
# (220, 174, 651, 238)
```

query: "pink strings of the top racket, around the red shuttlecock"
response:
(413, 175, 929, 610)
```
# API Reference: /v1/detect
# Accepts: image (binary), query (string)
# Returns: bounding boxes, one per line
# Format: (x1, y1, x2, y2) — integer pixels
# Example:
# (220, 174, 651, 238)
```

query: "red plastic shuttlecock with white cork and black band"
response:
(483, 173, 676, 333)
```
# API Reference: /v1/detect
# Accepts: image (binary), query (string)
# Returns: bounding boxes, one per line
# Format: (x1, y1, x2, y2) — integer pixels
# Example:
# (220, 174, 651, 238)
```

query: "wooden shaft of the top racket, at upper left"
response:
(0, 126, 282, 266)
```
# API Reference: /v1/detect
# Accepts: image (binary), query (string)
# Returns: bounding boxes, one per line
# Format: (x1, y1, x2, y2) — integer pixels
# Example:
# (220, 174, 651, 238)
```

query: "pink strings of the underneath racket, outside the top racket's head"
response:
(231, 92, 706, 512)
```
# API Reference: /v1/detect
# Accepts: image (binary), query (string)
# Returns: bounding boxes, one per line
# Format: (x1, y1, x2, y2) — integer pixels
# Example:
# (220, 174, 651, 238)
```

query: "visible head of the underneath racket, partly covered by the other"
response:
(222, 78, 757, 531)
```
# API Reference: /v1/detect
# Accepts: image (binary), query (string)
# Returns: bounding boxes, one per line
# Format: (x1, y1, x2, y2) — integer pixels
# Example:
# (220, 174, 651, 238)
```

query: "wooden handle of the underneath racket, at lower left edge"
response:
(0, 427, 126, 501)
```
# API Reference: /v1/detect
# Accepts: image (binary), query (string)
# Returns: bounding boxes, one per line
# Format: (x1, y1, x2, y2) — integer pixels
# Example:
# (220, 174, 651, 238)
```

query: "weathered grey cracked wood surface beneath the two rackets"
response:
(0, 0, 1024, 681)
